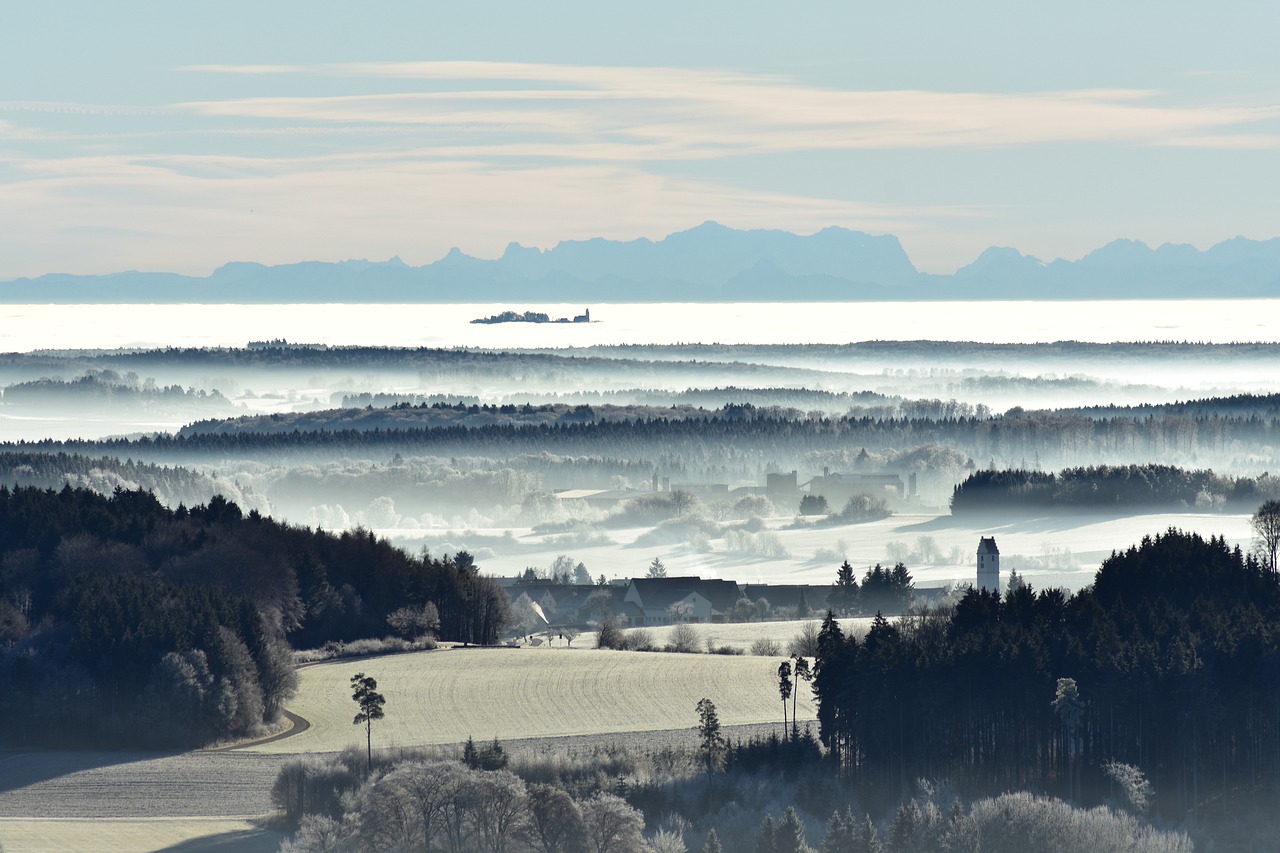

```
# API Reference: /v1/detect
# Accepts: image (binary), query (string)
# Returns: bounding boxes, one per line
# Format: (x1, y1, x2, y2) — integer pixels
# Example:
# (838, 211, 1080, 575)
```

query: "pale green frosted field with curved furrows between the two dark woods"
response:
(247, 648, 815, 753)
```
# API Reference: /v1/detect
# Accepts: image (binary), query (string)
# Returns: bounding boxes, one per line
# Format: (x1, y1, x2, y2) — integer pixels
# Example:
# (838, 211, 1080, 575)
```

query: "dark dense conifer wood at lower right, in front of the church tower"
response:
(814, 530, 1280, 820)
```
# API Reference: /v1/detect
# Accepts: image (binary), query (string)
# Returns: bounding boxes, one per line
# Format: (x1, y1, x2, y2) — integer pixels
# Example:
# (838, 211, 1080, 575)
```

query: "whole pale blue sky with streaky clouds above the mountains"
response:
(0, 0, 1280, 279)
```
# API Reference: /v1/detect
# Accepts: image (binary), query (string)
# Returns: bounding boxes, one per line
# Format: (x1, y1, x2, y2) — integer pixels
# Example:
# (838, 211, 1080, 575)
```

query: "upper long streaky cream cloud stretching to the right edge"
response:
(180, 61, 1280, 153)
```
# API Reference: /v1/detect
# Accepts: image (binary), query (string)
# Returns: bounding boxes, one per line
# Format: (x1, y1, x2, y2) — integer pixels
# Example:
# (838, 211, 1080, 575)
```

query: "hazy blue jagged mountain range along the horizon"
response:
(0, 222, 1280, 305)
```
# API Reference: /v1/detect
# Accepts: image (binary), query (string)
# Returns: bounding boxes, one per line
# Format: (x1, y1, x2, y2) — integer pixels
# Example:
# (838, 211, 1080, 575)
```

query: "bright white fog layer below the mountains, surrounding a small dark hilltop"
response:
(0, 300, 1280, 352)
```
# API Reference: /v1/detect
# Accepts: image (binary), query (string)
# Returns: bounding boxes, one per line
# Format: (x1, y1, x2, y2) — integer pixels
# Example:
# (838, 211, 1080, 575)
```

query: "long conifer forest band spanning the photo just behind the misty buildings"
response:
(8, 406, 1280, 466)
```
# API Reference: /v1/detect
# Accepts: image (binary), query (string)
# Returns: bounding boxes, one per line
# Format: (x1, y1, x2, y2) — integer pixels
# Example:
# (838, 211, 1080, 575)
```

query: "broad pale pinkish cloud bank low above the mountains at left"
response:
(0, 152, 972, 277)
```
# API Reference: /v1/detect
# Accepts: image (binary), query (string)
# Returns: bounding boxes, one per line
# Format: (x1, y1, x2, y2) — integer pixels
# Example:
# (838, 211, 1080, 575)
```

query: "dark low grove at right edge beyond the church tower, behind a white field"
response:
(951, 464, 1280, 515)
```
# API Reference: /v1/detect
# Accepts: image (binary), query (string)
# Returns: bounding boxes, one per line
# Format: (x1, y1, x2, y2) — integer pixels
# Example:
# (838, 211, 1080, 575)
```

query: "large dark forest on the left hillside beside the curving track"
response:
(0, 487, 509, 743)
